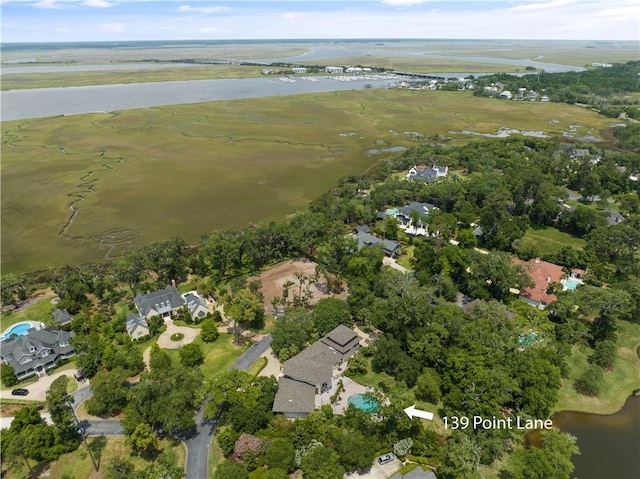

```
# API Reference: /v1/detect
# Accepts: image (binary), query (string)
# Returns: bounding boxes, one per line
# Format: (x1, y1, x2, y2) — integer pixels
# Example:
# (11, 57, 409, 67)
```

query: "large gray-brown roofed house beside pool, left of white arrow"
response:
(273, 325, 361, 419)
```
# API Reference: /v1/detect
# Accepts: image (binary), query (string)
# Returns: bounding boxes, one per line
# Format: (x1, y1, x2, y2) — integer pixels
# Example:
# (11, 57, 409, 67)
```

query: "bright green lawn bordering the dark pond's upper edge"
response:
(553, 321, 640, 414)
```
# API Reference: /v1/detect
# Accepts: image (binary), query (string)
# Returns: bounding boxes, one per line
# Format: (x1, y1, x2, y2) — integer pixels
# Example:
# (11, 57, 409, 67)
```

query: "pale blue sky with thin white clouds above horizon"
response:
(0, 0, 640, 42)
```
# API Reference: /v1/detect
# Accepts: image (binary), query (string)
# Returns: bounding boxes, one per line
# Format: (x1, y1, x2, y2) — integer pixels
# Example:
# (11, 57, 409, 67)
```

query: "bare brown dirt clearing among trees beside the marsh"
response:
(248, 259, 342, 313)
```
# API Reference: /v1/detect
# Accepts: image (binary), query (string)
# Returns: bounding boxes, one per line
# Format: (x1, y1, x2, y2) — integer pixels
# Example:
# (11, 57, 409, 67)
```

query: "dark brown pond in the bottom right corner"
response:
(553, 396, 640, 479)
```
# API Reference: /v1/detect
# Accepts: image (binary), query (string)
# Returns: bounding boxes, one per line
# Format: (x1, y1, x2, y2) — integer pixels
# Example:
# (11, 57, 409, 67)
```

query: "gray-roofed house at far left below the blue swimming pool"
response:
(0, 326, 76, 379)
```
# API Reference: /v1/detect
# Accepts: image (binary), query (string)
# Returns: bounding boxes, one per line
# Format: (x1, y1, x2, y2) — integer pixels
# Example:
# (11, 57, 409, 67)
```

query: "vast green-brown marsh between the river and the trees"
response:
(1, 89, 611, 272)
